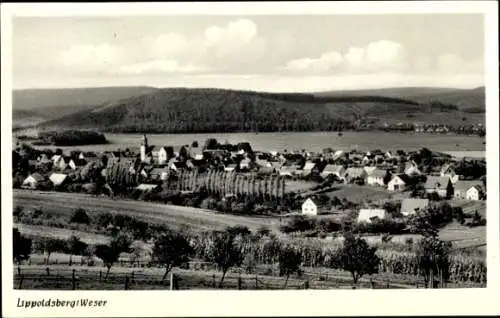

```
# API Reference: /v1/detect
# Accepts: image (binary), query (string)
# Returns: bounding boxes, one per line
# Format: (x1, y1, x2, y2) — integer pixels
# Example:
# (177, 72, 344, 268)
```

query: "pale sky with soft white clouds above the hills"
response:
(12, 14, 484, 91)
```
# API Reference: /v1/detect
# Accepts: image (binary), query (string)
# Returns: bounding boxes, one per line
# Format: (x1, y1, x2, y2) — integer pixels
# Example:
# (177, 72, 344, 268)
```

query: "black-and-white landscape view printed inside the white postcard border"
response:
(2, 0, 499, 316)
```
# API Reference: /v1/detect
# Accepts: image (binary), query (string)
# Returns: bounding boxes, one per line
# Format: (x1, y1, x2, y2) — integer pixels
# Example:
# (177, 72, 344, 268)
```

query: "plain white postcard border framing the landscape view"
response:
(1, 1, 500, 317)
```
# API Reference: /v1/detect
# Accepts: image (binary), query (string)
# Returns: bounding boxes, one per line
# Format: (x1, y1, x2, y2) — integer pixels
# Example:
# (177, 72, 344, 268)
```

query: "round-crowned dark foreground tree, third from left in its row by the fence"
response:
(153, 231, 193, 280)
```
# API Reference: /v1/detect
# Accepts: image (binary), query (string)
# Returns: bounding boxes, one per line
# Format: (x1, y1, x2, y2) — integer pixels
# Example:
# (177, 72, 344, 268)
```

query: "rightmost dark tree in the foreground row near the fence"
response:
(415, 237, 451, 288)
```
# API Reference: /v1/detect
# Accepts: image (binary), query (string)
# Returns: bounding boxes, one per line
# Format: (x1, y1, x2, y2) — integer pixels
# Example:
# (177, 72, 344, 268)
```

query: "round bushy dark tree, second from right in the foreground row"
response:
(337, 233, 380, 285)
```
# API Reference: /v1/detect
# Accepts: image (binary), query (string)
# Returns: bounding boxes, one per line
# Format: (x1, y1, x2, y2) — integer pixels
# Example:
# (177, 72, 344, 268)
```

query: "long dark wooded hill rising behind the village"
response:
(35, 88, 429, 133)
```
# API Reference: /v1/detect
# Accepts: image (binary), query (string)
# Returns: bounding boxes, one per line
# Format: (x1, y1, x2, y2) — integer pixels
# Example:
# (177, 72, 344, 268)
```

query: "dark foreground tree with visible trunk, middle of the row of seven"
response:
(205, 231, 244, 288)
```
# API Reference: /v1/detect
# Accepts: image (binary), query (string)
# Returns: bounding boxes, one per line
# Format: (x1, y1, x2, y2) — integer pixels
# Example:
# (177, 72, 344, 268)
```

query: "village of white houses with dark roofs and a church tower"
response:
(13, 135, 486, 227)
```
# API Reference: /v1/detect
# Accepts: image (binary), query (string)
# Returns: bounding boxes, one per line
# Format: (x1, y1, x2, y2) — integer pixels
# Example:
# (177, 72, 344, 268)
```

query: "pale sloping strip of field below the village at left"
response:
(13, 190, 279, 230)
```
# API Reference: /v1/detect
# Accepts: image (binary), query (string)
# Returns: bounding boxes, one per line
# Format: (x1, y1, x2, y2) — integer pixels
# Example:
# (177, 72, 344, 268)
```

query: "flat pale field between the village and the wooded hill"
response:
(25, 131, 485, 152)
